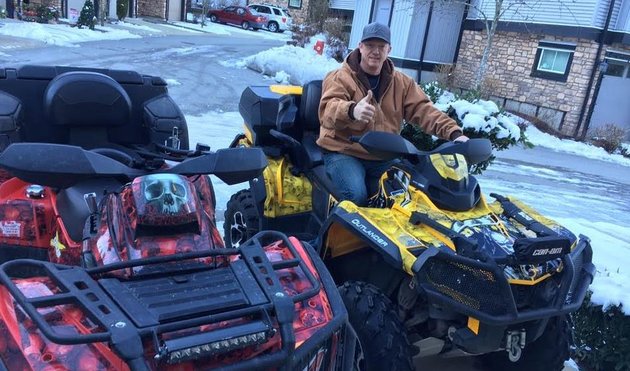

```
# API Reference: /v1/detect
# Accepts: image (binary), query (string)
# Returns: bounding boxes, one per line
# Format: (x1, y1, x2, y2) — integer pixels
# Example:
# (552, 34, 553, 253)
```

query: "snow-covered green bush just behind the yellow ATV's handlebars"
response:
(402, 82, 532, 173)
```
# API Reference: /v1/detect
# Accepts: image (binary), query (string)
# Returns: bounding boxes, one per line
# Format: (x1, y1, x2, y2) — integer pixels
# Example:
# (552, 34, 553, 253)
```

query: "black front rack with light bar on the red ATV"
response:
(0, 232, 347, 370)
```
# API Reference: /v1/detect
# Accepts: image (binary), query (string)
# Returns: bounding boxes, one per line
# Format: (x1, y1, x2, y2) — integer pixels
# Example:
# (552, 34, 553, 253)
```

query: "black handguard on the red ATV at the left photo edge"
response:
(0, 143, 142, 188)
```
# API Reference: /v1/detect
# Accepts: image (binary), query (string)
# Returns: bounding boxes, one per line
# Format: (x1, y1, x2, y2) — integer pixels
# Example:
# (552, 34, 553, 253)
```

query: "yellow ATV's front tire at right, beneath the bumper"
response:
(481, 316, 571, 371)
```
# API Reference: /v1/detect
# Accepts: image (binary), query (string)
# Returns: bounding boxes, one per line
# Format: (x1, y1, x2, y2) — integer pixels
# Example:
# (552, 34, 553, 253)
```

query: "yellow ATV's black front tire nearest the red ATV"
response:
(339, 281, 414, 371)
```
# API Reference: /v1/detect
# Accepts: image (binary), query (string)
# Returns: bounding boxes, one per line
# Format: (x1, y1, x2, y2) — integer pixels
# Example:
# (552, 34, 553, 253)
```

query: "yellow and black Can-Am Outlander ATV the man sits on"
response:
(224, 81, 595, 371)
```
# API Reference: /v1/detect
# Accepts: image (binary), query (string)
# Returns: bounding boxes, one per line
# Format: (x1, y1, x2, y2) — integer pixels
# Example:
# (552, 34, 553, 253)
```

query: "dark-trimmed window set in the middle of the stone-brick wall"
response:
(531, 41, 575, 81)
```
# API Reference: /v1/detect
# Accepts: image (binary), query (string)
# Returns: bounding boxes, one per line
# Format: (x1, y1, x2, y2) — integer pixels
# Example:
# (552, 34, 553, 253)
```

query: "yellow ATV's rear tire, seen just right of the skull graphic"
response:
(223, 189, 260, 248)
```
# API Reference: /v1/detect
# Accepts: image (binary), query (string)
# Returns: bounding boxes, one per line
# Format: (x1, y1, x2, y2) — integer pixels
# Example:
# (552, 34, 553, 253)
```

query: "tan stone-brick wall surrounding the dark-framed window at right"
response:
(455, 31, 599, 136)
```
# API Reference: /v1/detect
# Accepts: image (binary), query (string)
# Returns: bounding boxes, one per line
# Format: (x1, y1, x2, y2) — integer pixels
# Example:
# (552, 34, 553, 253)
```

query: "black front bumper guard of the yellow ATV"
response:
(412, 236, 595, 326)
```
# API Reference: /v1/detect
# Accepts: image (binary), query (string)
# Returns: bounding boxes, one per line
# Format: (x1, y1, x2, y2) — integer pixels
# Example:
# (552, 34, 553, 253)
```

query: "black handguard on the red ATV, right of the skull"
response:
(164, 148, 267, 185)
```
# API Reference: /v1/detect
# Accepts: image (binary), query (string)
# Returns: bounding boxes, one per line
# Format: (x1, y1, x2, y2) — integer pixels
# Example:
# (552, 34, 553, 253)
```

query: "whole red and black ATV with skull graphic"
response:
(0, 66, 361, 370)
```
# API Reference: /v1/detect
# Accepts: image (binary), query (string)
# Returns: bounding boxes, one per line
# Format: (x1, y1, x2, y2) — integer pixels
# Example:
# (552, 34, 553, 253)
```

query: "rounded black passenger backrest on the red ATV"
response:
(44, 71, 131, 149)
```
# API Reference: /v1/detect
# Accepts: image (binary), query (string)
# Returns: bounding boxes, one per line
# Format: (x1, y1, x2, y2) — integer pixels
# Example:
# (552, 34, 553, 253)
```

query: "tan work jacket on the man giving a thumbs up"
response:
(317, 49, 462, 160)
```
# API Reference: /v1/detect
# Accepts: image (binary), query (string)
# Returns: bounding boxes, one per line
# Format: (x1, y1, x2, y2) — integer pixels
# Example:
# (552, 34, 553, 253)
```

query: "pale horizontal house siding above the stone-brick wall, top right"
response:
(468, 0, 609, 28)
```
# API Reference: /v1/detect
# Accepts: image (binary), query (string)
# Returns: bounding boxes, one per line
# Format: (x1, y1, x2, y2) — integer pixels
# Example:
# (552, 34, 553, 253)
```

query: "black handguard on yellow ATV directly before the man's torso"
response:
(352, 131, 420, 160)
